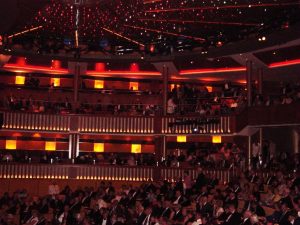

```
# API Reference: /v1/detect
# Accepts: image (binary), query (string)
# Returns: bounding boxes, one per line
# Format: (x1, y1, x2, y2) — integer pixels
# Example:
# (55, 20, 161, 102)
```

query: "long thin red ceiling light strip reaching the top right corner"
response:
(146, 2, 300, 13)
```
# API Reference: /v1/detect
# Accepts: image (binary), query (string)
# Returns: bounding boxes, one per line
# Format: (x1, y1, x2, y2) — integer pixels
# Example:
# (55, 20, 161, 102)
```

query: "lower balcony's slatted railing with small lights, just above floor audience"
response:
(0, 163, 235, 185)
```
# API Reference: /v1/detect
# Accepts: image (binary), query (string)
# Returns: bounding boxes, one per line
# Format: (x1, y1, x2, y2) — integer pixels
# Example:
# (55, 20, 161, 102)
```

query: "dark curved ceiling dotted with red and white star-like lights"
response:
(0, 0, 300, 53)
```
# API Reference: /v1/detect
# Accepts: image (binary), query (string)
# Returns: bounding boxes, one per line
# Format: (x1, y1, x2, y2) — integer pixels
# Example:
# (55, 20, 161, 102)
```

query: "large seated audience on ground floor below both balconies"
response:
(0, 167, 300, 225)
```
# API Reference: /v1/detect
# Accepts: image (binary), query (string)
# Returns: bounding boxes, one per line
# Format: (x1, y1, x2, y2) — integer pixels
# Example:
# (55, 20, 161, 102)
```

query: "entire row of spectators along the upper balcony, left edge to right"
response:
(0, 78, 300, 116)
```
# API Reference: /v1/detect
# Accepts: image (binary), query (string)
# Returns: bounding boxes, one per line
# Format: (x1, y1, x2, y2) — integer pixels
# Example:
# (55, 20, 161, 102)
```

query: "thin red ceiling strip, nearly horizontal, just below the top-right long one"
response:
(139, 18, 261, 27)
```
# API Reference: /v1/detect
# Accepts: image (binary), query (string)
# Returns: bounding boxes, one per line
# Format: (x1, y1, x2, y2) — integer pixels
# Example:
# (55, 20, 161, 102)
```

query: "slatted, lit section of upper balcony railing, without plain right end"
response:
(2, 111, 233, 134)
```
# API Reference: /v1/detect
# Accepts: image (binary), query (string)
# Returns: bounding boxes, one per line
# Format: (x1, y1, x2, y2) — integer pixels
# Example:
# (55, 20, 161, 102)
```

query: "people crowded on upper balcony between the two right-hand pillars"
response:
(167, 83, 245, 116)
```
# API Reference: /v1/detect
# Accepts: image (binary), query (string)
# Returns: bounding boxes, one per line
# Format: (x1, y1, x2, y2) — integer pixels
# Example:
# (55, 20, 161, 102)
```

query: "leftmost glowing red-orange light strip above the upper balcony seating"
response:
(3, 64, 68, 74)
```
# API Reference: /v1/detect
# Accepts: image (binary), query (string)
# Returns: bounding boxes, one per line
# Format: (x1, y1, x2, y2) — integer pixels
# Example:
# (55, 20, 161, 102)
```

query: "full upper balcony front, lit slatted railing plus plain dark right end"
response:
(2, 103, 300, 135)
